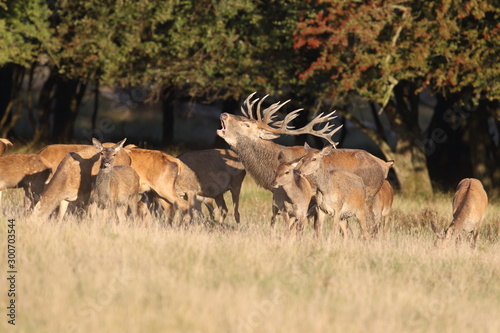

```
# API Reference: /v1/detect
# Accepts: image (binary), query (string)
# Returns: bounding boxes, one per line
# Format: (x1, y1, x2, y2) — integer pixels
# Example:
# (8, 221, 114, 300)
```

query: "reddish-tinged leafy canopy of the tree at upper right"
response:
(294, 0, 500, 102)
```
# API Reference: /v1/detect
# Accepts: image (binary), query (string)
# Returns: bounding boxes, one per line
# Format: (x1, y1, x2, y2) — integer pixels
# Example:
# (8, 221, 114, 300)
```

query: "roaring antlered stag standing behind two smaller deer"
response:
(217, 93, 392, 228)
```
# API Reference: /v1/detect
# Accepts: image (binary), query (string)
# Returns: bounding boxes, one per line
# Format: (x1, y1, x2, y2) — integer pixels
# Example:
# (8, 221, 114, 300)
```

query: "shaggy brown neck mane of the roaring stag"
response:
(233, 139, 295, 191)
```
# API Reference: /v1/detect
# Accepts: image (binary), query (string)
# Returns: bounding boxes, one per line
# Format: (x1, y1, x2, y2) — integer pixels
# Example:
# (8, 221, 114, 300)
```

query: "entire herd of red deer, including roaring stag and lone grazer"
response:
(0, 93, 488, 247)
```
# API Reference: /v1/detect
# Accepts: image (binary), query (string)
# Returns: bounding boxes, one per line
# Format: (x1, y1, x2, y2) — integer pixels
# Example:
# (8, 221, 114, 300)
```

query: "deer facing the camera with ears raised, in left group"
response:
(91, 138, 139, 221)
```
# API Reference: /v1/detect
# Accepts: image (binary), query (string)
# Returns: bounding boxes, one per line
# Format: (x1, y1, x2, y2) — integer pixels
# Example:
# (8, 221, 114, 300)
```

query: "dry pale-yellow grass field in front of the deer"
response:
(0, 177, 500, 333)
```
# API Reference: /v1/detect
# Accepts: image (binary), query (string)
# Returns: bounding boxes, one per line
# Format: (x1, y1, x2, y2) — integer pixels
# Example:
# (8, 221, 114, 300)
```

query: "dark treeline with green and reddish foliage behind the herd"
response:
(0, 0, 500, 195)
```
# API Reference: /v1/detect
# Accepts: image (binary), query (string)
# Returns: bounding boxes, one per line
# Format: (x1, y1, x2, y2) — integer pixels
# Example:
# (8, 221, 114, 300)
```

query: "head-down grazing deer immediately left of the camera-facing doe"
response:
(33, 143, 131, 220)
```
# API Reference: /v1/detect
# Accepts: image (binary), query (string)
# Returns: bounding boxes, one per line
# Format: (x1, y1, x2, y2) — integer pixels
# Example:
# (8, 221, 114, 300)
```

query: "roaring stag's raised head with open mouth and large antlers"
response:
(217, 93, 341, 147)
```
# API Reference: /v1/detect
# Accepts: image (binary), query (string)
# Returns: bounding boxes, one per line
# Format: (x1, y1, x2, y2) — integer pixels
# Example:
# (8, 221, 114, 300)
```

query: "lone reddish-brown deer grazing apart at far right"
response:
(431, 178, 488, 249)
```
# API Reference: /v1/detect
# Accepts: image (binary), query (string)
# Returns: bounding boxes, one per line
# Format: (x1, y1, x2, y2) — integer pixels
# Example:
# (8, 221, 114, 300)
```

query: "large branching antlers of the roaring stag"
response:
(241, 92, 342, 148)
